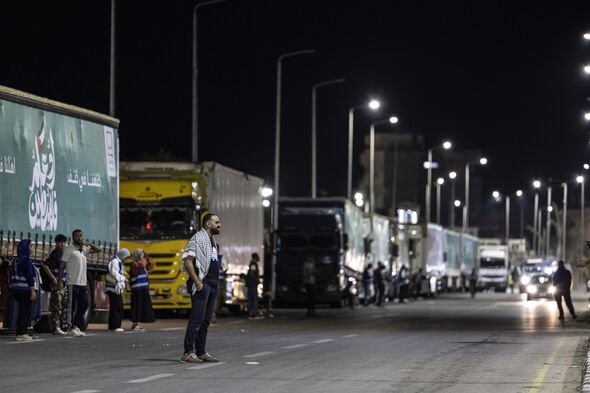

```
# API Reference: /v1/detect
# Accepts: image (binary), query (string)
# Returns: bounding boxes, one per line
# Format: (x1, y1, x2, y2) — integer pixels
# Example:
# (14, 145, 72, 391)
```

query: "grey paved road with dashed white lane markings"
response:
(0, 293, 590, 393)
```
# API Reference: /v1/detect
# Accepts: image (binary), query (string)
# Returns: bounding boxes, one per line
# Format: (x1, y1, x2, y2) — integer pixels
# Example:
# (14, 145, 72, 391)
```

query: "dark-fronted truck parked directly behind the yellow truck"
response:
(275, 198, 365, 306)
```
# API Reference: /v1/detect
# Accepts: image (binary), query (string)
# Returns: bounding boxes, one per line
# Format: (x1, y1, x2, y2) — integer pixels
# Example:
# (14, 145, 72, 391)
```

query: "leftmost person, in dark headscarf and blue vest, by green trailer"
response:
(10, 239, 37, 341)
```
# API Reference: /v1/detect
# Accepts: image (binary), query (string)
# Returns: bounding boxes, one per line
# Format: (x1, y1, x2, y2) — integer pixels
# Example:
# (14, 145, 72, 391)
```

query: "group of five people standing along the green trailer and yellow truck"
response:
(10, 229, 155, 341)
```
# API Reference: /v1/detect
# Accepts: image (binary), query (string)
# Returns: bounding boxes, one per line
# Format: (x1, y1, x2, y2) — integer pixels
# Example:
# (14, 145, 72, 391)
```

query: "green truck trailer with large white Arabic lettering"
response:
(0, 86, 119, 331)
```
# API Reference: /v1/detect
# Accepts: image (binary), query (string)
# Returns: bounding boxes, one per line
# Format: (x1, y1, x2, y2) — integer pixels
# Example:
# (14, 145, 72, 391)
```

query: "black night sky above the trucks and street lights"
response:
(0, 0, 590, 201)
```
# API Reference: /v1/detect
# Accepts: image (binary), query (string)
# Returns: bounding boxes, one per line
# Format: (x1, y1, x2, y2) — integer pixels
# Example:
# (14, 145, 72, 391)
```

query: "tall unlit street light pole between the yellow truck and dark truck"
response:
(276, 49, 315, 299)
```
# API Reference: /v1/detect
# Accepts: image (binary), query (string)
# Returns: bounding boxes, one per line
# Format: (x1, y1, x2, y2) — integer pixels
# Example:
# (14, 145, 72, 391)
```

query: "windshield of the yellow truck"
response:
(119, 199, 194, 239)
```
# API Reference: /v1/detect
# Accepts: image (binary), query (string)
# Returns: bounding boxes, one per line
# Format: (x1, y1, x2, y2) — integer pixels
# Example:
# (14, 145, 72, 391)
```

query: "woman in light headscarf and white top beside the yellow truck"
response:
(105, 248, 131, 333)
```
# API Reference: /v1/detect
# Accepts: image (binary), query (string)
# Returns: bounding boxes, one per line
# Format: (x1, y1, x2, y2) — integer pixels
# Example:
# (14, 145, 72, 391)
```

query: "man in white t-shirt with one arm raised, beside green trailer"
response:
(61, 229, 100, 337)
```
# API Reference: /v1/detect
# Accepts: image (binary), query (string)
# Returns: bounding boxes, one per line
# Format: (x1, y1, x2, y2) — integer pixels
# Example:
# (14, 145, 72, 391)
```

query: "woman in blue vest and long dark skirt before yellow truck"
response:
(129, 248, 156, 331)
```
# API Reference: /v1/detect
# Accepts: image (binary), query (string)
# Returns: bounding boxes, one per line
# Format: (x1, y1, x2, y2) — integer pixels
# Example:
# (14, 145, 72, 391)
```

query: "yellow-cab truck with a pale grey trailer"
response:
(120, 162, 264, 312)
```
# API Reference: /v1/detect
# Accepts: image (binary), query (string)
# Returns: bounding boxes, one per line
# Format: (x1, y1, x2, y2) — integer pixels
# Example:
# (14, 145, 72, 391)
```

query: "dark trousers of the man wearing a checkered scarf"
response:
(184, 282, 218, 356)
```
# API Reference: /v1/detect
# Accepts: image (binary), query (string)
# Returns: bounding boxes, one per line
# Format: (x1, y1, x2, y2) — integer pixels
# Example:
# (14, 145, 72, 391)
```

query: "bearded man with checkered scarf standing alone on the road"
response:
(180, 214, 221, 363)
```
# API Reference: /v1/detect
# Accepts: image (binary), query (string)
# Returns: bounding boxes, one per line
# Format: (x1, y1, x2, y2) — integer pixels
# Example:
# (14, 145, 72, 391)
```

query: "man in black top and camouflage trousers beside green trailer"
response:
(41, 233, 68, 336)
